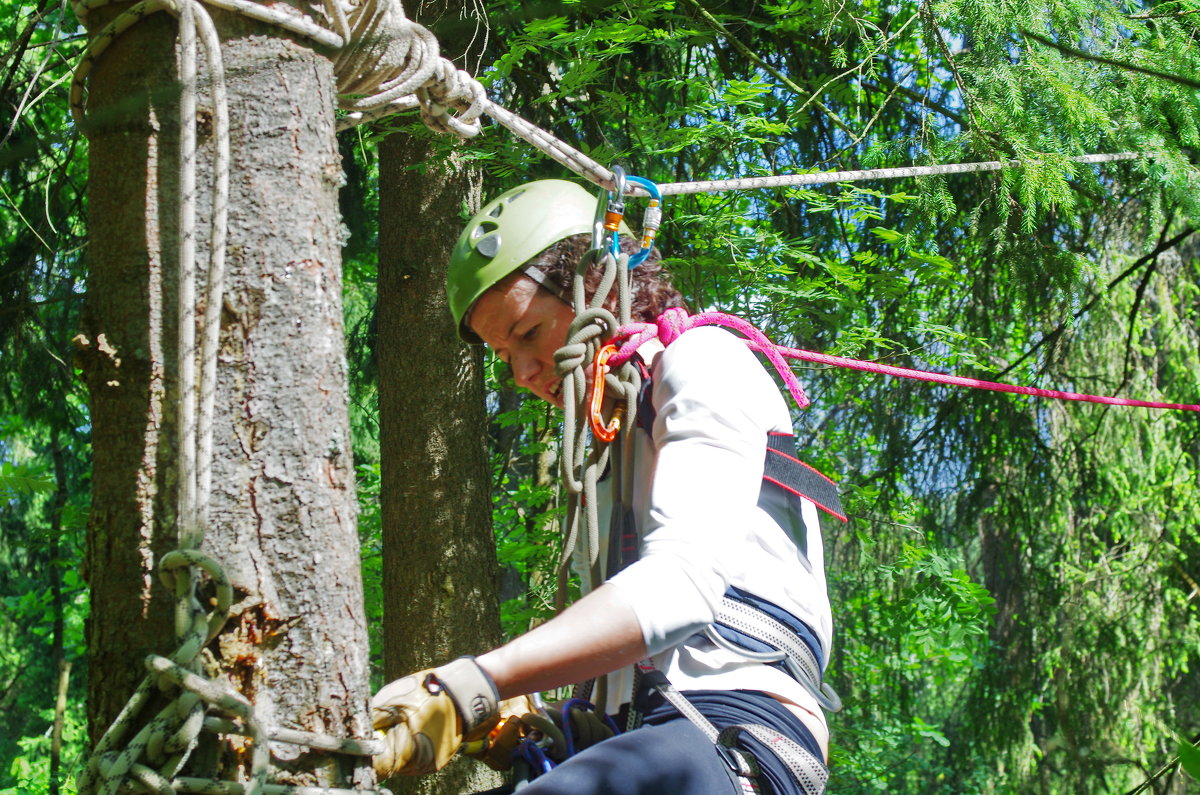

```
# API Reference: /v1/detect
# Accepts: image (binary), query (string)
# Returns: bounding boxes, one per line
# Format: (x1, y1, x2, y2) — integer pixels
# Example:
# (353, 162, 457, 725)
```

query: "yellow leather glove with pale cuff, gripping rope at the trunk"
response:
(371, 657, 499, 778)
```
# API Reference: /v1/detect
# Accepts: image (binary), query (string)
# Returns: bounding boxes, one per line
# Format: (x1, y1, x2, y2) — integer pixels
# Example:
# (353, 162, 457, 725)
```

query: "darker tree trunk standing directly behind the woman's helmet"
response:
(378, 9, 500, 793)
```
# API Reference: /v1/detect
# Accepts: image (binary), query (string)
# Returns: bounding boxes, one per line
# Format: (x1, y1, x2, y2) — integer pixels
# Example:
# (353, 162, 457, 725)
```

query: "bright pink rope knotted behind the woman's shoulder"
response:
(608, 309, 1200, 412)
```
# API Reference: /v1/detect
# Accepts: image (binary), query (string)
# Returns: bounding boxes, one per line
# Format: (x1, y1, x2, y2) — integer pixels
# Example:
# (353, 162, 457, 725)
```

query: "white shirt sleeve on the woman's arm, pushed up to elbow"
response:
(610, 327, 790, 654)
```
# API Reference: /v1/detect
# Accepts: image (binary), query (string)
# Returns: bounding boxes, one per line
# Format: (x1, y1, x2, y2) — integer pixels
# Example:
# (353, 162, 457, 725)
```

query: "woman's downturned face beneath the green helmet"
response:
(469, 275, 575, 408)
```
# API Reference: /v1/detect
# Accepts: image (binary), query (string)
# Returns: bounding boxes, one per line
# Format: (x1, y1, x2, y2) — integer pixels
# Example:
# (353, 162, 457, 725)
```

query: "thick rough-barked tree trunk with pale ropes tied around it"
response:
(83, 6, 373, 787)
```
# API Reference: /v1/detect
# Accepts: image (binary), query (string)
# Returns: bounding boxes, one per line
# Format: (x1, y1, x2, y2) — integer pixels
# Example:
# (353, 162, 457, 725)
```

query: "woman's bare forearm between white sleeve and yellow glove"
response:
(475, 585, 646, 699)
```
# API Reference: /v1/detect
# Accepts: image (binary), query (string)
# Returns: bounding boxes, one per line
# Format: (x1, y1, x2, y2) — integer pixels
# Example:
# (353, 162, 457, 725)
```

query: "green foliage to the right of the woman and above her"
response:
(458, 0, 1200, 793)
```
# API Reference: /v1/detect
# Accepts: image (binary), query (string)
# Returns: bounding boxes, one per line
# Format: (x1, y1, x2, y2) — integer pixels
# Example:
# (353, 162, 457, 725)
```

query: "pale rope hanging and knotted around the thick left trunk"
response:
(72, 0, 386, 795)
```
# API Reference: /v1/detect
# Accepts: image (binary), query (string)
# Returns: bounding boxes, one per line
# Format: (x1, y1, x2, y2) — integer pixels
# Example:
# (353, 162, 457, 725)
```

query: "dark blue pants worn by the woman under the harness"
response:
(477, 691, 821, 795)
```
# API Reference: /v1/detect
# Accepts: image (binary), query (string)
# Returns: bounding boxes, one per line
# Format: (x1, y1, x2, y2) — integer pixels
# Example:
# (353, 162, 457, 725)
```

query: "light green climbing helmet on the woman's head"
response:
(446, 179, 596, 345)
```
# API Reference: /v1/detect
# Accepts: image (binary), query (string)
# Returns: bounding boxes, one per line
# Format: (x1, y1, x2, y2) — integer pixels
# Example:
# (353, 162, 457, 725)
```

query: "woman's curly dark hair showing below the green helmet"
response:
(517, 233, 686, 323)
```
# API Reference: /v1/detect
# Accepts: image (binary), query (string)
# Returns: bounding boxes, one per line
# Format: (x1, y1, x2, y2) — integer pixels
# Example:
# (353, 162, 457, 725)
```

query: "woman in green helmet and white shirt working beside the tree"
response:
(373, 180, 838, 795)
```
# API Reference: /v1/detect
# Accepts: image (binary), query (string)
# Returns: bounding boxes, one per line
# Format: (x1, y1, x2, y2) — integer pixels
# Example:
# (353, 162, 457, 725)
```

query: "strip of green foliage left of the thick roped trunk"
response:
(0, 2, 89, 793)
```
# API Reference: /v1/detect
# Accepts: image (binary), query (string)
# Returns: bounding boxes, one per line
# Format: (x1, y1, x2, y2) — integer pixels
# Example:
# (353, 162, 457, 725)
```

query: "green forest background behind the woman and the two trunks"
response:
(0, 0, 1200, 795)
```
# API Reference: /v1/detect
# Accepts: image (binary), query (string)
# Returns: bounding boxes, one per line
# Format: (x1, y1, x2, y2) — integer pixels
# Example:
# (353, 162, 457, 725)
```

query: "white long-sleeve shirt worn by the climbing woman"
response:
(576, 327, 833, 730)
